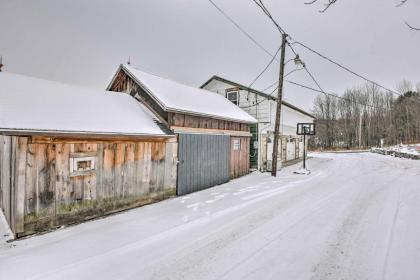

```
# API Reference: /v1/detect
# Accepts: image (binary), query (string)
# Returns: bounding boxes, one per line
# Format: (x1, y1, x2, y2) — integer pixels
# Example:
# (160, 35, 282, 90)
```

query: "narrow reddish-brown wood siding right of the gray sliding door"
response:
(230, 136, 250, 178)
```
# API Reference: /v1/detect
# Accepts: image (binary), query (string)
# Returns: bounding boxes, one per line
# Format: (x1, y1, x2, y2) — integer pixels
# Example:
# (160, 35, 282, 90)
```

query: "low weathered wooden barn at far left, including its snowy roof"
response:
(0, 72, 177, 237)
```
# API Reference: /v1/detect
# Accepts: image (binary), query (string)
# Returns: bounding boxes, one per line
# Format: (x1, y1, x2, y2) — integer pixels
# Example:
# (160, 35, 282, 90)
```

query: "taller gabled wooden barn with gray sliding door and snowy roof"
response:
(108, 65, 256, 194)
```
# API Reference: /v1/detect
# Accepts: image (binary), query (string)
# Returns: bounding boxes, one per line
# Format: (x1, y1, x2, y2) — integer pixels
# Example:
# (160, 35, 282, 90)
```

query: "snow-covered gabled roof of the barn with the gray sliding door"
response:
(111, 64, 257, 123)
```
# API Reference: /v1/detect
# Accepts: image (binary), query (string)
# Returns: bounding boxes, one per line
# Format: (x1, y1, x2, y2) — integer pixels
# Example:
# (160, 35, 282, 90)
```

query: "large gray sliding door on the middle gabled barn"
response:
(177, 134, 230, 195)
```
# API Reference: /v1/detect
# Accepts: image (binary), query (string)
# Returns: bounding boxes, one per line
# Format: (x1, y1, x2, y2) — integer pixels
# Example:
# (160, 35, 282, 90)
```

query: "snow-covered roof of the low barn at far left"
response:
(0, 72, 171, 136)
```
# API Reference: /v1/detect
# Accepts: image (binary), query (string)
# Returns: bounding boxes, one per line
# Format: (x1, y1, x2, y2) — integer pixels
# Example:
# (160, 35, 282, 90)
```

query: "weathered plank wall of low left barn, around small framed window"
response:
(2, 137, 177, 236)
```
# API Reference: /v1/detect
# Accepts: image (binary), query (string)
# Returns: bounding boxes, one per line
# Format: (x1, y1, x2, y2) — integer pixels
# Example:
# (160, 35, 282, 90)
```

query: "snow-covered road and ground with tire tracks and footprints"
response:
(0, 153, 420, 280)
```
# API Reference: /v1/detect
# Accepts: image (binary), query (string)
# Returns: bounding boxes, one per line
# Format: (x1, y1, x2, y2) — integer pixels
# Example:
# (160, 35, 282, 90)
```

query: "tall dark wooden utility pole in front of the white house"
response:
(271, 33, 287, 177)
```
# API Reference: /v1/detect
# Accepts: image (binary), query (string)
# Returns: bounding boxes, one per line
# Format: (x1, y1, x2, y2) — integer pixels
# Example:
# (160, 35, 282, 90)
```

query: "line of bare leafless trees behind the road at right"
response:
(309, 80, 420, 149)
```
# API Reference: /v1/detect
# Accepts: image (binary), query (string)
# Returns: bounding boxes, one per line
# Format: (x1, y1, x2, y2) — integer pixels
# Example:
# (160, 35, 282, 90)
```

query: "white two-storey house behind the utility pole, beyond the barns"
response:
(201, 76, 315, 171)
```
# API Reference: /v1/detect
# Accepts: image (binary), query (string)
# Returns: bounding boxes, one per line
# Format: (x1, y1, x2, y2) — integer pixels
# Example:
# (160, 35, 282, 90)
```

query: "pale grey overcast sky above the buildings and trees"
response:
(0, 0, 420, 110)
